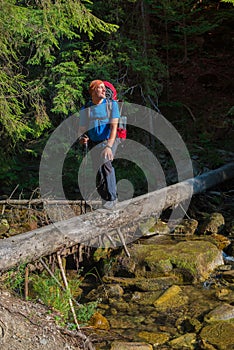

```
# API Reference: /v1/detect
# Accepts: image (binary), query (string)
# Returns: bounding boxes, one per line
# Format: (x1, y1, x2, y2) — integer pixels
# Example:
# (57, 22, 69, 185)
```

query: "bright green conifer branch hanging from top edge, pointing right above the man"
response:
(25, 0, 118, 65)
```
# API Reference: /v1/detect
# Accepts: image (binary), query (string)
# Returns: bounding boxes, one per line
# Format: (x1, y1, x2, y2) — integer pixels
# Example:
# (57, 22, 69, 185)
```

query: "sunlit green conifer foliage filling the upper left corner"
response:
(0, 0, 118, 153)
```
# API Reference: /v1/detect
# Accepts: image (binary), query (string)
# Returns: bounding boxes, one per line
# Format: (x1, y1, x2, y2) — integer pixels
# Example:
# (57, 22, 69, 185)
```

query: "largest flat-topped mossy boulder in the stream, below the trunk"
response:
(130, 240, 223, 282)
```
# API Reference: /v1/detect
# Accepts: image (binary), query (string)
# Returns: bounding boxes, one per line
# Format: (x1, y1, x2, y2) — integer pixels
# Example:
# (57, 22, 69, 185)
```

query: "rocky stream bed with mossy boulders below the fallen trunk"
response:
(72, 182, 234, 350)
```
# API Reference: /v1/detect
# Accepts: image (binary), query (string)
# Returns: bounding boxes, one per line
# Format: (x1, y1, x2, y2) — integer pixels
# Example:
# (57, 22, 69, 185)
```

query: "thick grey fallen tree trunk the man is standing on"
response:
(0, 162, 234, 271)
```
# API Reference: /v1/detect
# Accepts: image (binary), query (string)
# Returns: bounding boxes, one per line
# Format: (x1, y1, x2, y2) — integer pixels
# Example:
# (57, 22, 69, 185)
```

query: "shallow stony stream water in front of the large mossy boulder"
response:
(79, 241, 234, 350)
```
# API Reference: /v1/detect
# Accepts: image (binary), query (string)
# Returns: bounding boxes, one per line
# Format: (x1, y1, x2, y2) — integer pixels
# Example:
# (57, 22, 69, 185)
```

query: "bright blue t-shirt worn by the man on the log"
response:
(80, 99, 120, 142)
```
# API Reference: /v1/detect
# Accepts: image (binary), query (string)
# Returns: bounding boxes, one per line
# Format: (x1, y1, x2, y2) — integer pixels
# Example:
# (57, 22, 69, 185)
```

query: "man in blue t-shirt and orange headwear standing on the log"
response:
(79, 80, 120, 209)
